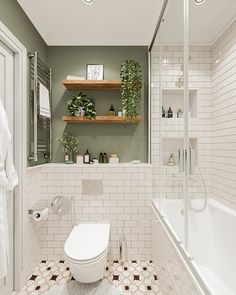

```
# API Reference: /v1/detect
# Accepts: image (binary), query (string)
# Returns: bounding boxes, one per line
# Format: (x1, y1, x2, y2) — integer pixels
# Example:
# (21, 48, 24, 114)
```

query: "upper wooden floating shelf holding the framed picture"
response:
(62, 80, 121, 90)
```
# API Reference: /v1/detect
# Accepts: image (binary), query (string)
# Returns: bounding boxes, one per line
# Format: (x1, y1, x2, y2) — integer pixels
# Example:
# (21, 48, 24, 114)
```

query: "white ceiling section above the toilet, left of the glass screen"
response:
(17, 0, 163, 45)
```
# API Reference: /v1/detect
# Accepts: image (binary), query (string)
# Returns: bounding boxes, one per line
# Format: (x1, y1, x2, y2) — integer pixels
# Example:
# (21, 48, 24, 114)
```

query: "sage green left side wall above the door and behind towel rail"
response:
(0, 0, 48, 166)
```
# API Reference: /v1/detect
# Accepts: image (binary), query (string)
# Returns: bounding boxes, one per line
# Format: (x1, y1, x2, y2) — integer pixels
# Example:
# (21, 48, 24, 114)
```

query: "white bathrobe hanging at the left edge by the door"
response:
(0, 98, 18, 279)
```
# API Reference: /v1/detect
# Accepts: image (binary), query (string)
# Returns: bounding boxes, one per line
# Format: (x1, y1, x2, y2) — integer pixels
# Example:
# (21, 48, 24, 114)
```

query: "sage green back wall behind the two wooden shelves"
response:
(48, 46, 148, 162)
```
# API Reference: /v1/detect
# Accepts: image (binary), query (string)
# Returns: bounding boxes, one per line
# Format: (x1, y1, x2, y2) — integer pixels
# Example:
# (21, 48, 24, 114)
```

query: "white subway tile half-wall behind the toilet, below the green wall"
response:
(30, 164, 152, 260)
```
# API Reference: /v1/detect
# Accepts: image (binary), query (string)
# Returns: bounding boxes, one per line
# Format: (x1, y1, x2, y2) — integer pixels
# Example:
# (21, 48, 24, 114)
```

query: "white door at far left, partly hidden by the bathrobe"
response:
(0, 41, 14, 295)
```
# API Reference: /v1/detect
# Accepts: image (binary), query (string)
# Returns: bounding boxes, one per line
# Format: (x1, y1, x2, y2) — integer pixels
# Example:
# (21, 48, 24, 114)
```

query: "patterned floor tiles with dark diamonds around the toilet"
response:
(12, 260, 160, 295)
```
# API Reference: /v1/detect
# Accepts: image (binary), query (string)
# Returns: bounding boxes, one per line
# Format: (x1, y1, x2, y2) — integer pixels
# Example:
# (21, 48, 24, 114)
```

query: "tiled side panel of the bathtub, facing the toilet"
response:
(152, 213, 202, 295)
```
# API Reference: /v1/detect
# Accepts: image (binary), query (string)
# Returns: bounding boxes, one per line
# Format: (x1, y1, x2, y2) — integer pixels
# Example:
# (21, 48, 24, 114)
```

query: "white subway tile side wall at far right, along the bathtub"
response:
(212, 22, 236, 209)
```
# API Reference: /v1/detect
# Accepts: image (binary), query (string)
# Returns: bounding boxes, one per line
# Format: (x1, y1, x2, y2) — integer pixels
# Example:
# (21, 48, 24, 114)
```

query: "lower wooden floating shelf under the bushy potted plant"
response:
(62, 116, 142, 124)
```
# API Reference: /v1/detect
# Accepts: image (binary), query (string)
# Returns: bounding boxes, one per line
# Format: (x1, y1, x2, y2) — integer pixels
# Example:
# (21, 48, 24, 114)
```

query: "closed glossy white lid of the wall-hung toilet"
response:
(64, 224, 110, 261)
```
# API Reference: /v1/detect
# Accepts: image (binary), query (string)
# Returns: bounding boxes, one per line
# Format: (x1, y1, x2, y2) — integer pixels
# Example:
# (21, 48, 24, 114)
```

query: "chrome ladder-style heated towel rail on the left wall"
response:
(28, 51, 52, 162)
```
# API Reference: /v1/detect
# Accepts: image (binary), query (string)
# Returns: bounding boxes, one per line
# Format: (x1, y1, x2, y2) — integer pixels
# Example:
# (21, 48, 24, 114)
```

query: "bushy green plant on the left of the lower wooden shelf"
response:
(67, 91, 96, 119)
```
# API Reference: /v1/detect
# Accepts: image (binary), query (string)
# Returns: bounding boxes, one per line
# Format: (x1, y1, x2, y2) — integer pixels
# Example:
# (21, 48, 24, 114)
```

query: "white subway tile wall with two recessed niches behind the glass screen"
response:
(152, 46, 212, 198)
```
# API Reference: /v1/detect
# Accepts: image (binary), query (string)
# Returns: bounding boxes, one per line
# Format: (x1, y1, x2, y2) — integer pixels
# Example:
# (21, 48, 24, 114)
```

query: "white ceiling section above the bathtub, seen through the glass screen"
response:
(162, 0, 236, 44)
